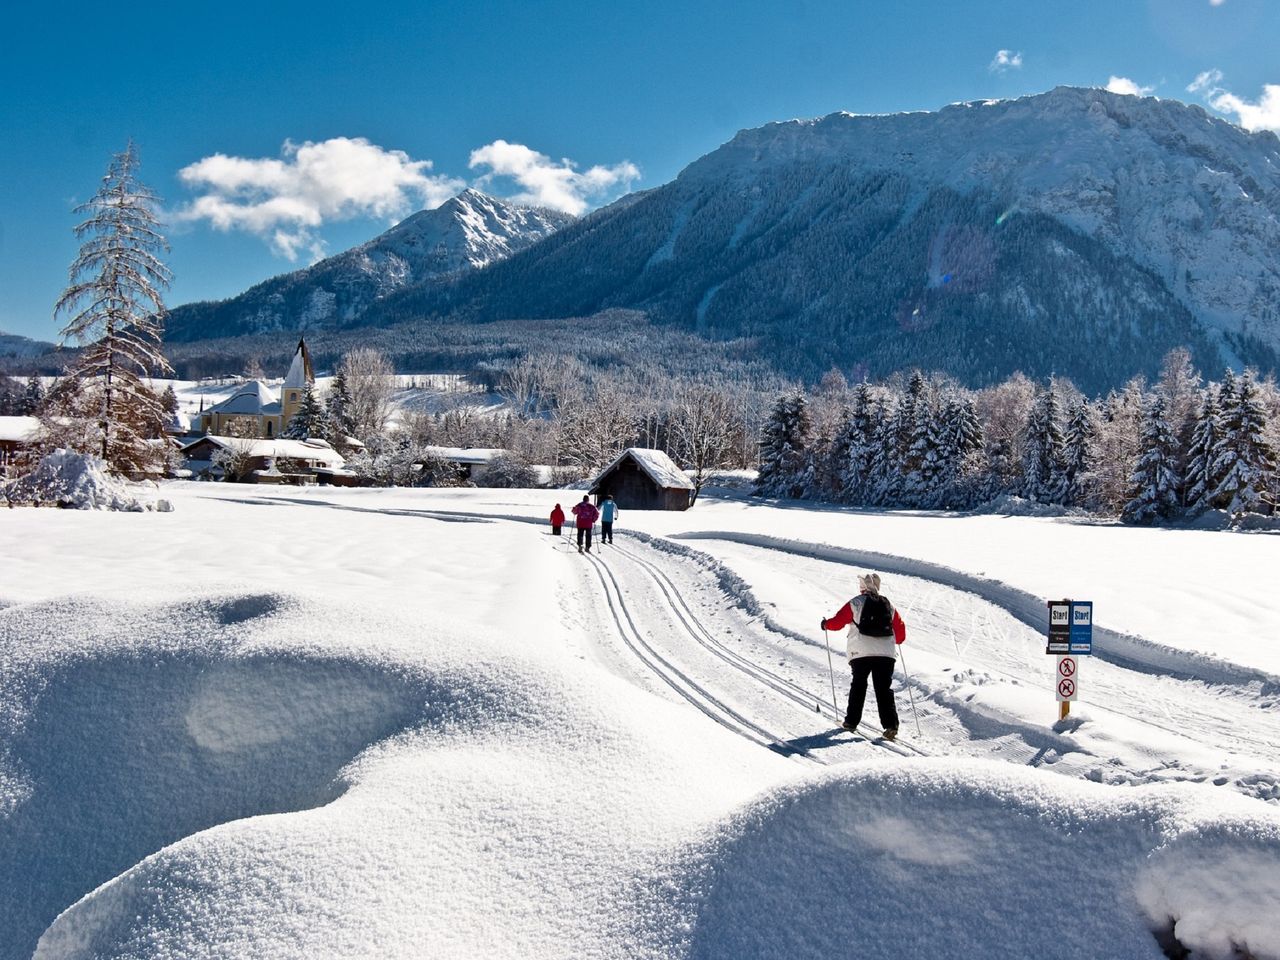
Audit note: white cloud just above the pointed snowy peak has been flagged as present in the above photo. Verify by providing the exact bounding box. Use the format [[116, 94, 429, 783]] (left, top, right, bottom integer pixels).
[[470, 140, 640, 215]]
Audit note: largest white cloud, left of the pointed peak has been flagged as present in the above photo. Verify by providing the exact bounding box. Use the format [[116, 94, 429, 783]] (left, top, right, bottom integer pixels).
[[173, 137, 466, 260]]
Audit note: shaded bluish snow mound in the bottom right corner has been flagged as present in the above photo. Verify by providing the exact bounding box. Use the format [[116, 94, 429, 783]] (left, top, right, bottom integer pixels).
[[689, 760, 1280, 960]]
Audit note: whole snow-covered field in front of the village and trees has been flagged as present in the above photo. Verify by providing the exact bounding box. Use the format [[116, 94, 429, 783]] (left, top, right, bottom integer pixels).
[[0, 483, 1280, 960]]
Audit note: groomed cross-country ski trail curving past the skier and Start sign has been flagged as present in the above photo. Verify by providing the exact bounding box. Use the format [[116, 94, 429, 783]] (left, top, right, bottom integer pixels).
[[235, 497, 1280, 800]]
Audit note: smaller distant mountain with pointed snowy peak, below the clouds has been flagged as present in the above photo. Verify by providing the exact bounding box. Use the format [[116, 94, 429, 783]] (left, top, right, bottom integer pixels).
[[165, 189, 573, 342]]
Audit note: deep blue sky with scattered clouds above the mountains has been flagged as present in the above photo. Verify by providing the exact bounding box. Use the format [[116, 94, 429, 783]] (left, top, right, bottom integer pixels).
[[0, 0, 1280, 339]]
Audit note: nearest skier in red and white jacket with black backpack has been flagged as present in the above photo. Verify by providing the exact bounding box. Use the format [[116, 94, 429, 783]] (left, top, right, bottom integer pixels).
[[822, 573, 906, 740]]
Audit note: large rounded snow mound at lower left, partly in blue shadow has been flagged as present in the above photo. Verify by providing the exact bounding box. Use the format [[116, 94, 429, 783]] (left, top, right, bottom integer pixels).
[[0, 593, 790, 960]]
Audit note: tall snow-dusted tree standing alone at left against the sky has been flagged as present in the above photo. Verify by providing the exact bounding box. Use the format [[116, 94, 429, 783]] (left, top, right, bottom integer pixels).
[[54, 142, 172, 474]]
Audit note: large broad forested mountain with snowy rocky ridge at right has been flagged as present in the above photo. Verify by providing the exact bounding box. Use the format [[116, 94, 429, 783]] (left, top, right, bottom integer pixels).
[[356, 87, 1280, 389]]
